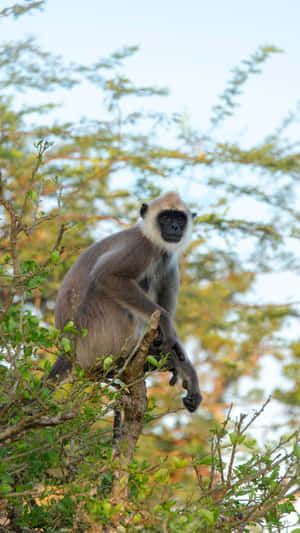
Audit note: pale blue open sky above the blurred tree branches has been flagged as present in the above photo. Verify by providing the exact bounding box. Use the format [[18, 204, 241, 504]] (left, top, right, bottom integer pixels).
[[0, 0, 300, 142]]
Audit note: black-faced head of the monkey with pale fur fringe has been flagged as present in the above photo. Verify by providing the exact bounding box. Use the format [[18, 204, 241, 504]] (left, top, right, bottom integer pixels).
[[140, 192, 196, 253]]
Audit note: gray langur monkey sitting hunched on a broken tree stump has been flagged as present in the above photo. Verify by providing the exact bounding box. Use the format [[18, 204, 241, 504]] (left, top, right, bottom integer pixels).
[[49, 192, 202, 412]]
